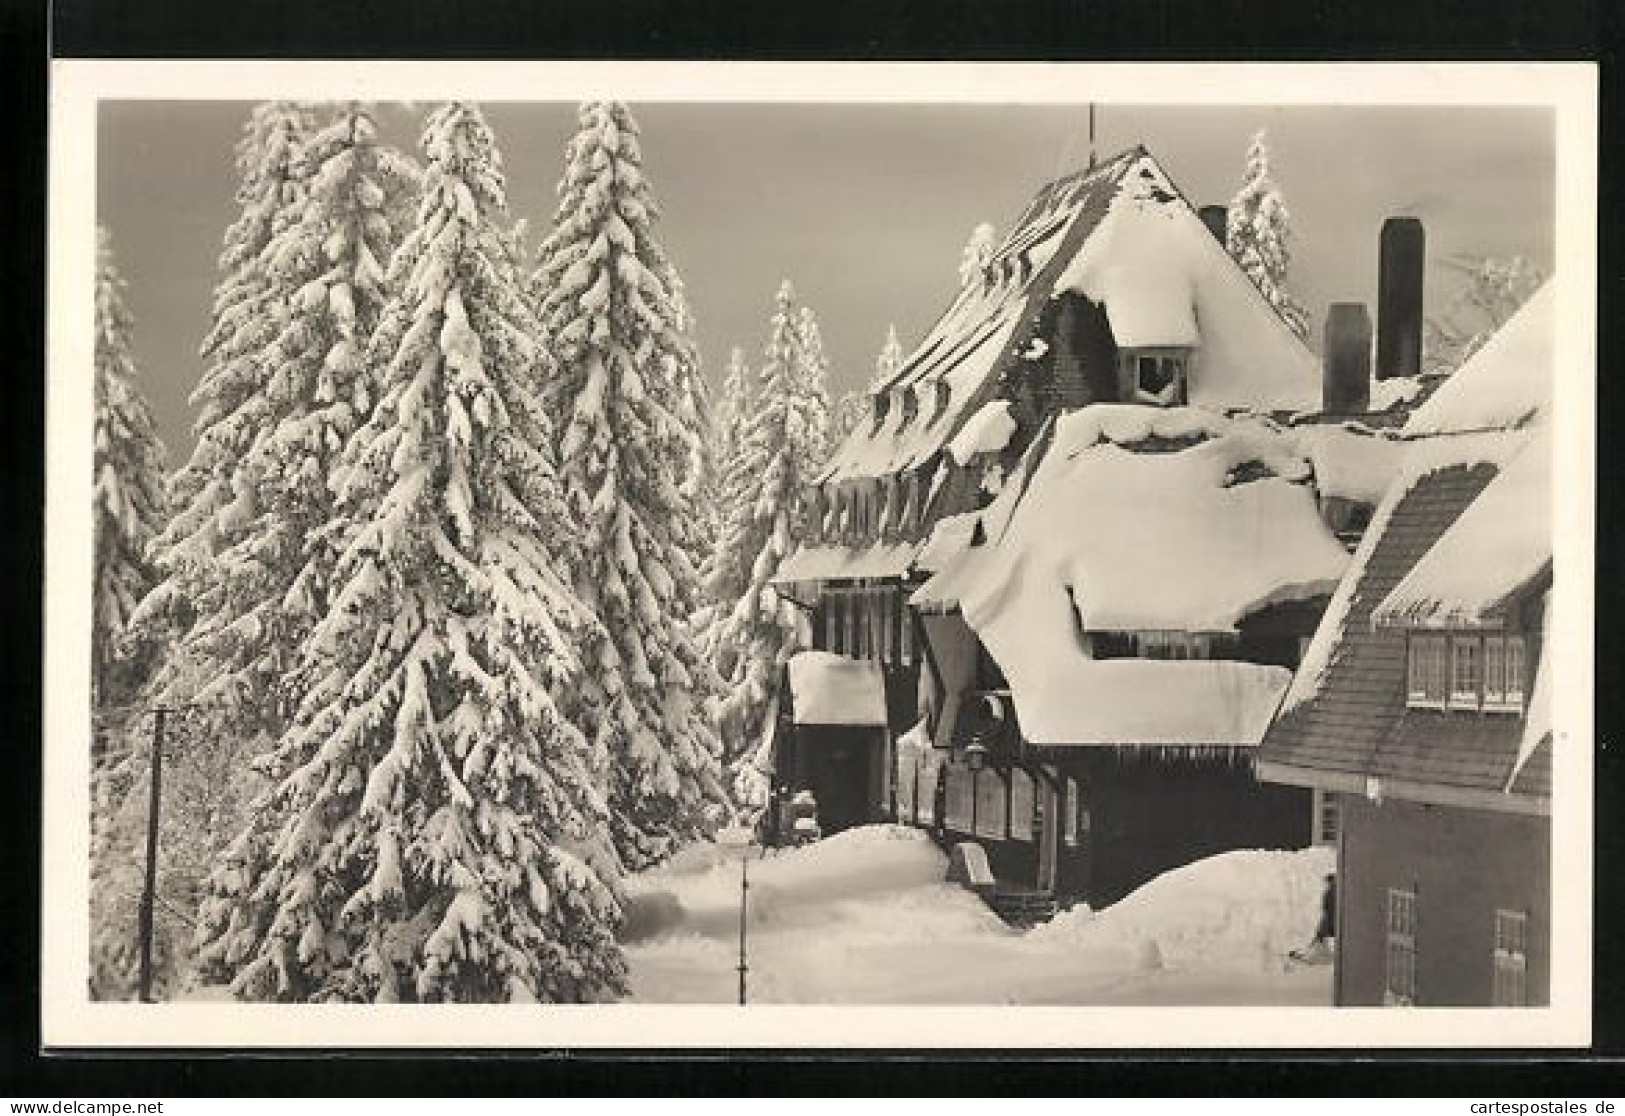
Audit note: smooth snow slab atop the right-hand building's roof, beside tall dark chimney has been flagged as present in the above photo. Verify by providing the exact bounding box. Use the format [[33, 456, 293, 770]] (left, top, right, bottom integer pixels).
[[1404, 279, 1557, 435]]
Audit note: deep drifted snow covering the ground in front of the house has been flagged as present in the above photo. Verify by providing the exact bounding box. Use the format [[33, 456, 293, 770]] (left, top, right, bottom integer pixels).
[[627, 825, 1333, 1006]]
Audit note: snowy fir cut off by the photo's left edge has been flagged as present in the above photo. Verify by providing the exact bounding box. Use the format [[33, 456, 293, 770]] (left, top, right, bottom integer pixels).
[[91, 229, 166, 710]]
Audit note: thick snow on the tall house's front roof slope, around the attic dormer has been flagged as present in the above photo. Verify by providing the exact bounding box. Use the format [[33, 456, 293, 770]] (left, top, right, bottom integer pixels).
[[1055, 156, 1321, 411]]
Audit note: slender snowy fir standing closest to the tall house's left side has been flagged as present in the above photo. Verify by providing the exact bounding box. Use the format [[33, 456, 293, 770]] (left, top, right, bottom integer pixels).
[[707, 283, 826, 786]]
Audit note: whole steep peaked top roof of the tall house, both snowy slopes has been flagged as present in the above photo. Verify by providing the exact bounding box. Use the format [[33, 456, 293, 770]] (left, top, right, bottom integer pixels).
[[819, 148, 1320, 481]]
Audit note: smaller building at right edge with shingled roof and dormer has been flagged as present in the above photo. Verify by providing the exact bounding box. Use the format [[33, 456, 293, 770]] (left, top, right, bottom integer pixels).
[[1259, 284, 1555, 1006]]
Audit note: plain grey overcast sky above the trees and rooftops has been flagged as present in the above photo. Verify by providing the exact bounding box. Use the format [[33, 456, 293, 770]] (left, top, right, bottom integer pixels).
[[96, 101, 1555, 465]]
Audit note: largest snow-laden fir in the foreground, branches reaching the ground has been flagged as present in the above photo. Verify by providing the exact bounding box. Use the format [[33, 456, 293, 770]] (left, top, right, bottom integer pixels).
[[188, 104, 626, 1001]]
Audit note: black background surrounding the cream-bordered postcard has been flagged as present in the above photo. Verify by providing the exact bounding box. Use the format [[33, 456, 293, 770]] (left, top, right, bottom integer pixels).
[[0, 0, 1625, 1103]]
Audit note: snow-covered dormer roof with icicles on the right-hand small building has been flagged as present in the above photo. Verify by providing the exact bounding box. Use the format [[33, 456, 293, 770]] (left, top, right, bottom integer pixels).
[[1372, 427, 1552, 627]]
